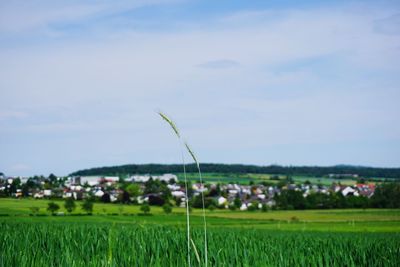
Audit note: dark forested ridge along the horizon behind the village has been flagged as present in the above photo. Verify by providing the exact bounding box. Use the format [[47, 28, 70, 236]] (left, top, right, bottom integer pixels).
[[70, 163, 400, 178]]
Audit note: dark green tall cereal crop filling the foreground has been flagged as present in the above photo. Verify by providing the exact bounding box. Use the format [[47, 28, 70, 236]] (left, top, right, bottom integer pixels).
[[0, 222, 400, 266]]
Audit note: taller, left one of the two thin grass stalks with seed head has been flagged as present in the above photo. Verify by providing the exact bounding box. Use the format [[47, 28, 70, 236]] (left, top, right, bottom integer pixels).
[[157, 111, 191, 266]]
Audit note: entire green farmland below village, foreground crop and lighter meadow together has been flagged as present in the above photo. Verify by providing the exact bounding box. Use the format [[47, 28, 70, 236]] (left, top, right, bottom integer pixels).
[[0, 199, 400, 266]]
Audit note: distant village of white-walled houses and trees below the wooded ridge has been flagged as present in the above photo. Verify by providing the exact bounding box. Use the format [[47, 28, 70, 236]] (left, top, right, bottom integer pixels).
[[0, 174, 384, 210]]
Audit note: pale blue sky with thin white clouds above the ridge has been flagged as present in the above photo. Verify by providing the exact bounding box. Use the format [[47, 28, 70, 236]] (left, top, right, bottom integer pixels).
[[0, 0, 400, 176]]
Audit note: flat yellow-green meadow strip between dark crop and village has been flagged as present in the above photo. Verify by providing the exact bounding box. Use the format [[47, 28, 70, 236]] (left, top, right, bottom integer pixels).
[[0, 199, 400, 232]]
